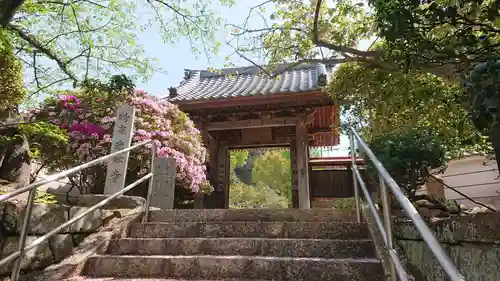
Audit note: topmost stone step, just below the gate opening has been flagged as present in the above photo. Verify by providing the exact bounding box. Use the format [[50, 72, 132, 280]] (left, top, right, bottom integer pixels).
[[149, 208, 355, 222]]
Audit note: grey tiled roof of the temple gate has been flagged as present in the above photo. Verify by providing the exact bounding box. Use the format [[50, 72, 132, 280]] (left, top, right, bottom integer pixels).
[[169, 63, 335, 102]]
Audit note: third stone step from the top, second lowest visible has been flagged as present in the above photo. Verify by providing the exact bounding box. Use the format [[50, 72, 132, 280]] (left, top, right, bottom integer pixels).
[[107, 238, 376, 258]]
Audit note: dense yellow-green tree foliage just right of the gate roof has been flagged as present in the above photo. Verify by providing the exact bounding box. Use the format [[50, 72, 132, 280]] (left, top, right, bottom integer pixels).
[[328, 63, 487, 156]]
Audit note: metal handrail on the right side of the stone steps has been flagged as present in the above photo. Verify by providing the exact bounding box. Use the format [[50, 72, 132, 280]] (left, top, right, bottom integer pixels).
[[350, 128, 465, 281]]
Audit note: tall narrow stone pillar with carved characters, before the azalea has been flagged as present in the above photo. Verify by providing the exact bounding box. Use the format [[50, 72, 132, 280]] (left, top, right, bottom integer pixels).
[[104, 104, 135, 194]]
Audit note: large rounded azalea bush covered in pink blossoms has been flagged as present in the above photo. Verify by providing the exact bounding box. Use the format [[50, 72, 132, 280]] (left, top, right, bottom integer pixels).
[[28, 90, 211, 193]]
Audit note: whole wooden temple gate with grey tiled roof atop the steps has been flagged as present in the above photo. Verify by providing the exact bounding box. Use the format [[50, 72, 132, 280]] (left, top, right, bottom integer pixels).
[[168, 64, 339, 209]]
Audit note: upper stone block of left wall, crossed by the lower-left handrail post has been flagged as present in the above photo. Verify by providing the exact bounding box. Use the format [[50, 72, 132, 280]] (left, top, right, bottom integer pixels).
[[16, 203, 68, 235]]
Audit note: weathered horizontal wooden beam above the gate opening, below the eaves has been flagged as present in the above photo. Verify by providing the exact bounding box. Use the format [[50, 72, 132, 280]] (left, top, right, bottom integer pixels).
[[207, 117, 297, 131]]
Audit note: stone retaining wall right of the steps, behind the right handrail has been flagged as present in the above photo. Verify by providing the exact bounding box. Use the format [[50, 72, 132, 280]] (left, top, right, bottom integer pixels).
[[394, 213, 500, 281]]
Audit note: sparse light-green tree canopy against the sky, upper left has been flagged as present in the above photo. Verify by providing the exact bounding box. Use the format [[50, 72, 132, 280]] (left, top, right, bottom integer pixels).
[[0, 0, 234, 96]]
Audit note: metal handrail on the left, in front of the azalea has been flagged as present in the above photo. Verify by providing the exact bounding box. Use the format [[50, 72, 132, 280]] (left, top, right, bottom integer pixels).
[[0, 140, 156, 281]]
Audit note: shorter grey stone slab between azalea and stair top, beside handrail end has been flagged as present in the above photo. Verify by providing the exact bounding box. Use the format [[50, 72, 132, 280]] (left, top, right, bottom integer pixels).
[[151, 157, 177, 210]]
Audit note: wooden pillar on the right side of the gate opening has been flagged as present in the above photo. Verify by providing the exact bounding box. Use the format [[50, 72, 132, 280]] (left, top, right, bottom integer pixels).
[[295, 116, 311, 209]]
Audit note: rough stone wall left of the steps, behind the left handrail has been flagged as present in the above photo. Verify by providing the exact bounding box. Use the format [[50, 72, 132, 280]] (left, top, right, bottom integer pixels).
[[0, 195, 144, 279]]
